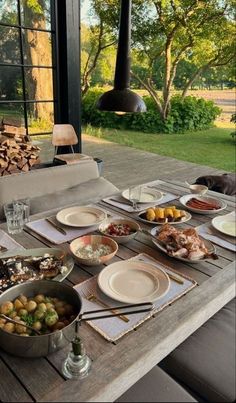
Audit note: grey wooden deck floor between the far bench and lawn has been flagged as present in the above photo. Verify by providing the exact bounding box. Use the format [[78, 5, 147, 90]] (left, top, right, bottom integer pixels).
[[34, 135, 225, 189]]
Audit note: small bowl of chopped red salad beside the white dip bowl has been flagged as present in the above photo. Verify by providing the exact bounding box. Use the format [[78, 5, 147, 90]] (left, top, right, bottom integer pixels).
[[99, 218, 141, 243]]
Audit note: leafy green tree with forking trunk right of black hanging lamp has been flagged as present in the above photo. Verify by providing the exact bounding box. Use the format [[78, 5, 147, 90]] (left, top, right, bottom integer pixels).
[[92, 0, 235, 120]]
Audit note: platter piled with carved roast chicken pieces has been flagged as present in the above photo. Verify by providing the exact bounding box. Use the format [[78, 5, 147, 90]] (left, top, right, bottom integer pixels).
[[151, 224, 218, 263]]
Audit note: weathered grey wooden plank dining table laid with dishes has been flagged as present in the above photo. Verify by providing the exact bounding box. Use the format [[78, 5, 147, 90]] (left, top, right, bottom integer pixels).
[[0, 181, 235, 402]]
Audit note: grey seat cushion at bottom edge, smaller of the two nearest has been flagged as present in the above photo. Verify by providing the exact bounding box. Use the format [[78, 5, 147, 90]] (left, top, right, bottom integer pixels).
[[117, 367, 196, 402]]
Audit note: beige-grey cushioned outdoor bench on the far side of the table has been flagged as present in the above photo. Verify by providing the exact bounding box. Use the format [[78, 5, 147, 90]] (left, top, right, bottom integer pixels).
[[0, 159, 118, 220]]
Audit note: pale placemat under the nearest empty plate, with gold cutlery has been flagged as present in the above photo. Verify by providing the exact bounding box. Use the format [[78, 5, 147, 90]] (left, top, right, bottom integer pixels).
[[74, 253, 197, 341]]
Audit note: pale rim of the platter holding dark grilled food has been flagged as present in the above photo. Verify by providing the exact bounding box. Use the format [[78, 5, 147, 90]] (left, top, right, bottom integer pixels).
[[0, 248, 74, 288]]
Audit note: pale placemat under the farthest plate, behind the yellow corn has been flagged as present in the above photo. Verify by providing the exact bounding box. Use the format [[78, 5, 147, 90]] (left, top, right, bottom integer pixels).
[[103, 193, 178, 213]]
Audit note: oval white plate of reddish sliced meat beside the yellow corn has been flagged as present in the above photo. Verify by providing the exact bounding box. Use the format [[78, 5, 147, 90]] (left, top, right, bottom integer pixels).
[[179, 194, 227, 214]]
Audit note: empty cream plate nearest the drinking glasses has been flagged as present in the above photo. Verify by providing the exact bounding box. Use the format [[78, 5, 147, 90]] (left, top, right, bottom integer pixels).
[[56, 206, 107, 227]]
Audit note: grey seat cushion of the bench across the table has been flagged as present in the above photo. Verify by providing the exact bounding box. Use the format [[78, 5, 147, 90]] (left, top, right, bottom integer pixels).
[[30, 177, 118, 214]]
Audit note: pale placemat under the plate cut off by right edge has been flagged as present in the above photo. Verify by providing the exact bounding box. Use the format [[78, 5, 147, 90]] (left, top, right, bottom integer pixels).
[[197, 213, 236, 252]]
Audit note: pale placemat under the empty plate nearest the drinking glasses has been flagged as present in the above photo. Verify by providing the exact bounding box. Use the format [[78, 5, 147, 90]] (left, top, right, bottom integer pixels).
[[26, 218, 99, 245]]
